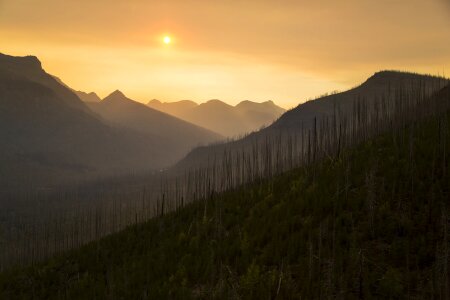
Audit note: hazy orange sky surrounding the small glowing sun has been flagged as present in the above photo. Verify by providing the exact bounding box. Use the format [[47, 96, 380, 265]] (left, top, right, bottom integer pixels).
[[0, 0, 450, 108]]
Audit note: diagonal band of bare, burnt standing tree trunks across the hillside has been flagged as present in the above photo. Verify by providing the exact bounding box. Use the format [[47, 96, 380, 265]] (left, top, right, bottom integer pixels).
[[0, 72, 450, 271]]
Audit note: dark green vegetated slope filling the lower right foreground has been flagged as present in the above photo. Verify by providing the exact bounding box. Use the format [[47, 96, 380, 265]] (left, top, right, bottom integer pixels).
[[0, 114, 450, 299]]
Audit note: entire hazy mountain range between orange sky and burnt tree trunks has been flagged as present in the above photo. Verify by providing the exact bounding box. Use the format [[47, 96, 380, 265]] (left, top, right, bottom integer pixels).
[[0, 54, 448, 190]]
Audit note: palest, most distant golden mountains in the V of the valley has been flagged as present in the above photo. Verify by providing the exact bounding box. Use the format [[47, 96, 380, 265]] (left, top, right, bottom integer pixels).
[[148, 100, 285, 137]]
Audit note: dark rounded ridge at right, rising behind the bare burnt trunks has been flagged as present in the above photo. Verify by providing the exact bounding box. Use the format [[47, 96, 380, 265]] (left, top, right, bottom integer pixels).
[[177, 71, 448, 169]]
